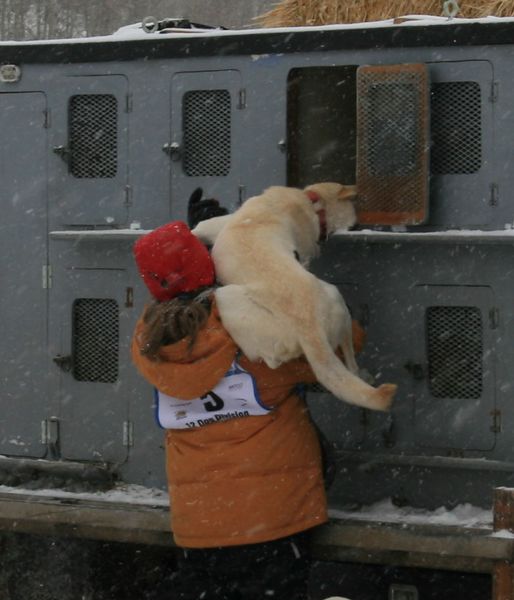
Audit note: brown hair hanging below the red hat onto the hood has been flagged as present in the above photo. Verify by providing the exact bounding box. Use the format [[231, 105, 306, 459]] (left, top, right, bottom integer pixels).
[[140, 297, 211, 361]]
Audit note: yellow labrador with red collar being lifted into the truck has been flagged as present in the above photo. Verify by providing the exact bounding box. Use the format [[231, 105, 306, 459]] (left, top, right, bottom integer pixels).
[[193, 183, 397, 410]]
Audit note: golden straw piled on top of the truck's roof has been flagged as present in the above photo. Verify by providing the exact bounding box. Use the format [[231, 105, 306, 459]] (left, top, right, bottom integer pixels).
[[256, 0, 514, 27]]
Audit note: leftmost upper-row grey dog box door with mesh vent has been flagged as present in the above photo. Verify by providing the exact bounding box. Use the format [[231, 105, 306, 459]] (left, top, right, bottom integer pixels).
[[50, 75, 129, 228]]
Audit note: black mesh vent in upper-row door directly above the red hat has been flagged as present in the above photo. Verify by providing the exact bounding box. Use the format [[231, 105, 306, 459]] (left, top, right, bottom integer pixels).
[[183, 90, 231, 177]]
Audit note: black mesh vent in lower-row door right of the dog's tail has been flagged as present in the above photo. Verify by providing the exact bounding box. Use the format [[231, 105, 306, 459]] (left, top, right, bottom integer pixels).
[[426, 306, 483, 398]]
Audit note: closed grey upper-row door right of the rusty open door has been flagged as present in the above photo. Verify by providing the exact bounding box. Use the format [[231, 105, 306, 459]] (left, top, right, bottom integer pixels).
[[429, 60, 497, 227]]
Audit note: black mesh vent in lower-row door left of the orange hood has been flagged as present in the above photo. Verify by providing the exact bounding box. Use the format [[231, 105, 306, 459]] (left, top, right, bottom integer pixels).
[[73, 298, 119, 383]]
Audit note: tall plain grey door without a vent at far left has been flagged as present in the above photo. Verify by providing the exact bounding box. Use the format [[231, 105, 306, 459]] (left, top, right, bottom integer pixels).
[[0, 92, 52, 457]]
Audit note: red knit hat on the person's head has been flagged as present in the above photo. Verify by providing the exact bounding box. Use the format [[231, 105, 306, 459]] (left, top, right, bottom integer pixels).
[[134, 221, 215, 302]]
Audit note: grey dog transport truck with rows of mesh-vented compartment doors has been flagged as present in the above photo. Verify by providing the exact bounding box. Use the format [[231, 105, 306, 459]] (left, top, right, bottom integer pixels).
[[0, 16, 514, 600]]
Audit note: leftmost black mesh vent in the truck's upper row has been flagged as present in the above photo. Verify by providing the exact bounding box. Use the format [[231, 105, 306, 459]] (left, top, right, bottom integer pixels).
[[69, 94, 118, 178]]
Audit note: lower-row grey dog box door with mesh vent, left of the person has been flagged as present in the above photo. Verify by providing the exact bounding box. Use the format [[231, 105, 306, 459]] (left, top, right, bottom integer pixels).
[[50, 266, 131, 463]]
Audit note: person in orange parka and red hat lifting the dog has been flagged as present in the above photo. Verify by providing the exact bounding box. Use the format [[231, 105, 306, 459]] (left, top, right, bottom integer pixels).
[[132, 216, 360, 600]]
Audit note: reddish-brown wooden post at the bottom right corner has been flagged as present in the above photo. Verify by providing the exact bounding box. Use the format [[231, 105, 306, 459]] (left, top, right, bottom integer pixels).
[[493, 487, 514, 600]]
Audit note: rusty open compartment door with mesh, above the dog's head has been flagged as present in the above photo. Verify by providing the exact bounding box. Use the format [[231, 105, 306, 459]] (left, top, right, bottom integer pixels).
[[357, 64, 430, 225]]
